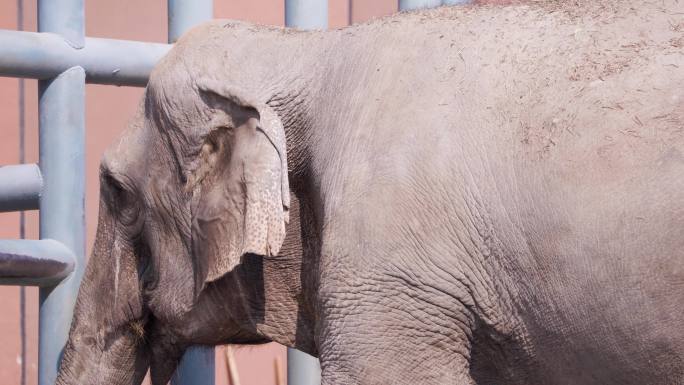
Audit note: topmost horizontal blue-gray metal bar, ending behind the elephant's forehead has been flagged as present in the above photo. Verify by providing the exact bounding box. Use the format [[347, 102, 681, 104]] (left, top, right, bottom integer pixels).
[[0, 30, 171, 87]]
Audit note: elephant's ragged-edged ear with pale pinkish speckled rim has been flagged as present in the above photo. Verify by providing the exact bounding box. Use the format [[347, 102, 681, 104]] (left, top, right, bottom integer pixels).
[[187, 79, 290, 293]]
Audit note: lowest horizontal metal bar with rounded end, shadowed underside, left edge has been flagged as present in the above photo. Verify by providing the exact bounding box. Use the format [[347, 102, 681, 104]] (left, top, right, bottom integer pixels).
[[0, 239, 76, 286]]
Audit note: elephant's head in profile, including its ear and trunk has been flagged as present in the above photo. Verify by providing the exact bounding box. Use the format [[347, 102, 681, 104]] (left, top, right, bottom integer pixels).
[[57, 25, 308, 384]]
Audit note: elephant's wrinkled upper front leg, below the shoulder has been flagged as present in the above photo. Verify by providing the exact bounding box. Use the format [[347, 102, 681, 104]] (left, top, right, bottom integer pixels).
[[318, 274, 474, 385]]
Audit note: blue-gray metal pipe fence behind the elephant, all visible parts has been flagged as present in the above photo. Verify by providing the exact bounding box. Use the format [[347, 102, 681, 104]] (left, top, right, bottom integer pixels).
[[0, 0, 468, 385]]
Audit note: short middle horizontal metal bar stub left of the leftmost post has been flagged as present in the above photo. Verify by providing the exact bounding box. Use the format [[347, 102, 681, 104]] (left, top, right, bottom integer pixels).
[[0, 164, 43, 212]]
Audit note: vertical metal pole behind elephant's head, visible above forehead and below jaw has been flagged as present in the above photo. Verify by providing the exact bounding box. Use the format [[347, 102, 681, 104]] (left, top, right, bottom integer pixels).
[[168, 0, 215, 385]]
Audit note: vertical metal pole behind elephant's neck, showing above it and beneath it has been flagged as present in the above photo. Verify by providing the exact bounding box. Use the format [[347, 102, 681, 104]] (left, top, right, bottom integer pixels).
[[285, 0, 324, 385]]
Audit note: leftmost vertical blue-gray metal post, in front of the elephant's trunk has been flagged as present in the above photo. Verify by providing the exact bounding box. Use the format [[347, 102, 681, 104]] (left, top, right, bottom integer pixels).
[[38, 0, 85, 385]]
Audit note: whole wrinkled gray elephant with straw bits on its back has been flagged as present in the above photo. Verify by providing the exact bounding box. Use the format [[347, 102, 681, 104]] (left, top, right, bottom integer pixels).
[[58, 0, 684, 385]]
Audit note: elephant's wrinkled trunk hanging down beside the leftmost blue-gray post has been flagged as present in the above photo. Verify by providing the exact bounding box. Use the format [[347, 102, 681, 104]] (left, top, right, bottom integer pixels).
[[57, 195, 149, 385]]
